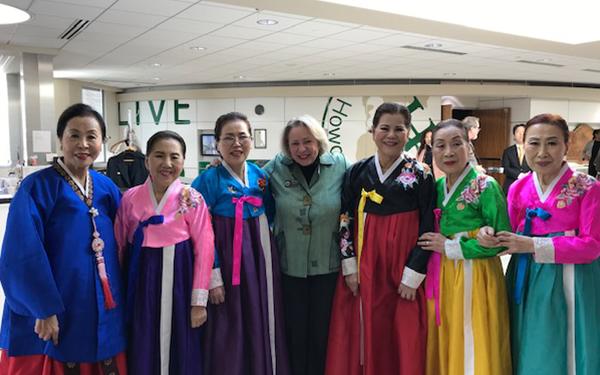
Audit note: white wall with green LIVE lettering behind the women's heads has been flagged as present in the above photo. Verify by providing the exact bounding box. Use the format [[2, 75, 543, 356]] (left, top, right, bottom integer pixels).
[[113, 93, 440, 178]]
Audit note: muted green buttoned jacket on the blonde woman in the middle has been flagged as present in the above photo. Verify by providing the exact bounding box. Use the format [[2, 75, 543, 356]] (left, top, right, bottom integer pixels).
[[263, 152, 350, 277]]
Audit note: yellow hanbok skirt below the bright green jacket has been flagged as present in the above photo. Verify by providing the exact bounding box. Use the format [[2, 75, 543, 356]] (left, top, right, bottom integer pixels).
[[427, 255, 512, 375]]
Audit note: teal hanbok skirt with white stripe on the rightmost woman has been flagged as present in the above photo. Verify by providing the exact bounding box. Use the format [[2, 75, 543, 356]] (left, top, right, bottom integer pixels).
[[506, 236, 600, 375]]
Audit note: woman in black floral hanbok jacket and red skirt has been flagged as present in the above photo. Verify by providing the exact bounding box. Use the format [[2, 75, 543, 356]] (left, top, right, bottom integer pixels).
[[326, 103, 436, 375]]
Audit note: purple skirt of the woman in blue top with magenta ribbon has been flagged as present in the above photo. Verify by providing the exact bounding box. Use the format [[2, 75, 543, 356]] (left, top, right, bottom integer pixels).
[[203, 215, 290, 375]]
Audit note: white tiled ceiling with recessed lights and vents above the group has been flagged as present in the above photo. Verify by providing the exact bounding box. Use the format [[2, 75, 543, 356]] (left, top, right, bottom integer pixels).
[[0, 0, 600, 88]]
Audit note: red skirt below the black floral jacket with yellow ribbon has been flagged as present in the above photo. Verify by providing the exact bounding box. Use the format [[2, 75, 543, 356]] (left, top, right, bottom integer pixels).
[[325, 211, 427, 375]]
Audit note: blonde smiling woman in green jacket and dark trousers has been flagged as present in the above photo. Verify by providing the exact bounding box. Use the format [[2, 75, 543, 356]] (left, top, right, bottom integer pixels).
[[263, 115, 350, 375]]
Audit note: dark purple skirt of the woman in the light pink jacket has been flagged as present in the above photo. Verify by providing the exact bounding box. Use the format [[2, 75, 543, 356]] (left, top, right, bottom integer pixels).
[[128, 239, 203, 375]]
